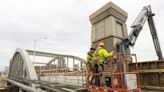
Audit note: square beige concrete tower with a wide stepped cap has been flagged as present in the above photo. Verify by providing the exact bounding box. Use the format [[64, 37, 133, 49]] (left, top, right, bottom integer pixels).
[[89, 2, 130, 53]]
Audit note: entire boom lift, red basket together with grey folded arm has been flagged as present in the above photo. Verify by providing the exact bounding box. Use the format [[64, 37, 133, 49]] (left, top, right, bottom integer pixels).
[[84, 5, 163, 92]]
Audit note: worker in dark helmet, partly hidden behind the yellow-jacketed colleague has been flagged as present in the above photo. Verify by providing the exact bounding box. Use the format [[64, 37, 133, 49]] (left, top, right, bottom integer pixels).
[[86, 48, 95, 84]]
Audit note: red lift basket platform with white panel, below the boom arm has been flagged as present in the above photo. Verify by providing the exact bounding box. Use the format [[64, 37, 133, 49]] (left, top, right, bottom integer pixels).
[[84, 53, 141, 92]]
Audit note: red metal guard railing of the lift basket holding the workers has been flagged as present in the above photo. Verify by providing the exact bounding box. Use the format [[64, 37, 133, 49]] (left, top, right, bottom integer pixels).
[[84, 54, 141, 92]]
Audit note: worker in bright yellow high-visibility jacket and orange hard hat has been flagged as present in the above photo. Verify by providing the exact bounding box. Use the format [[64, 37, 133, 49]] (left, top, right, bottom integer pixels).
[[93, 42, 113, 86]]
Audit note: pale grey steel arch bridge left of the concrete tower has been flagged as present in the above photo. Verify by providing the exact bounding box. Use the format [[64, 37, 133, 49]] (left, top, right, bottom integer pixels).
[[6, 48, 86, 92]]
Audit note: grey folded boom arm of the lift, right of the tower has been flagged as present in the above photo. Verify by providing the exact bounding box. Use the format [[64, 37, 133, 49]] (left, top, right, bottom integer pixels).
[[116, 5, 163, 60]]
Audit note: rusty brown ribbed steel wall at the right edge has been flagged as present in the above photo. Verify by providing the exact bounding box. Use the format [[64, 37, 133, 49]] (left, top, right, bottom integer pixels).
[[128, 60, 164, 92]]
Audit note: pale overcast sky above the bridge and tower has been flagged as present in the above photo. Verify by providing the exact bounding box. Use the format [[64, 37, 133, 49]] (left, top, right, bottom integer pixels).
[[0, 0, 164, 70]]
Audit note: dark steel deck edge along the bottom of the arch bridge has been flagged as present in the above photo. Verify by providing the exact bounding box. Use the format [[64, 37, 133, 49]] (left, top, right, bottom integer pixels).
[[7, 78, 82, 92]]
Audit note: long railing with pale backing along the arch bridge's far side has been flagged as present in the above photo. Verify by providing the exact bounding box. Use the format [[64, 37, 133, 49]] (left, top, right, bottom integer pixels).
[[32, 63, 86, 86]]
